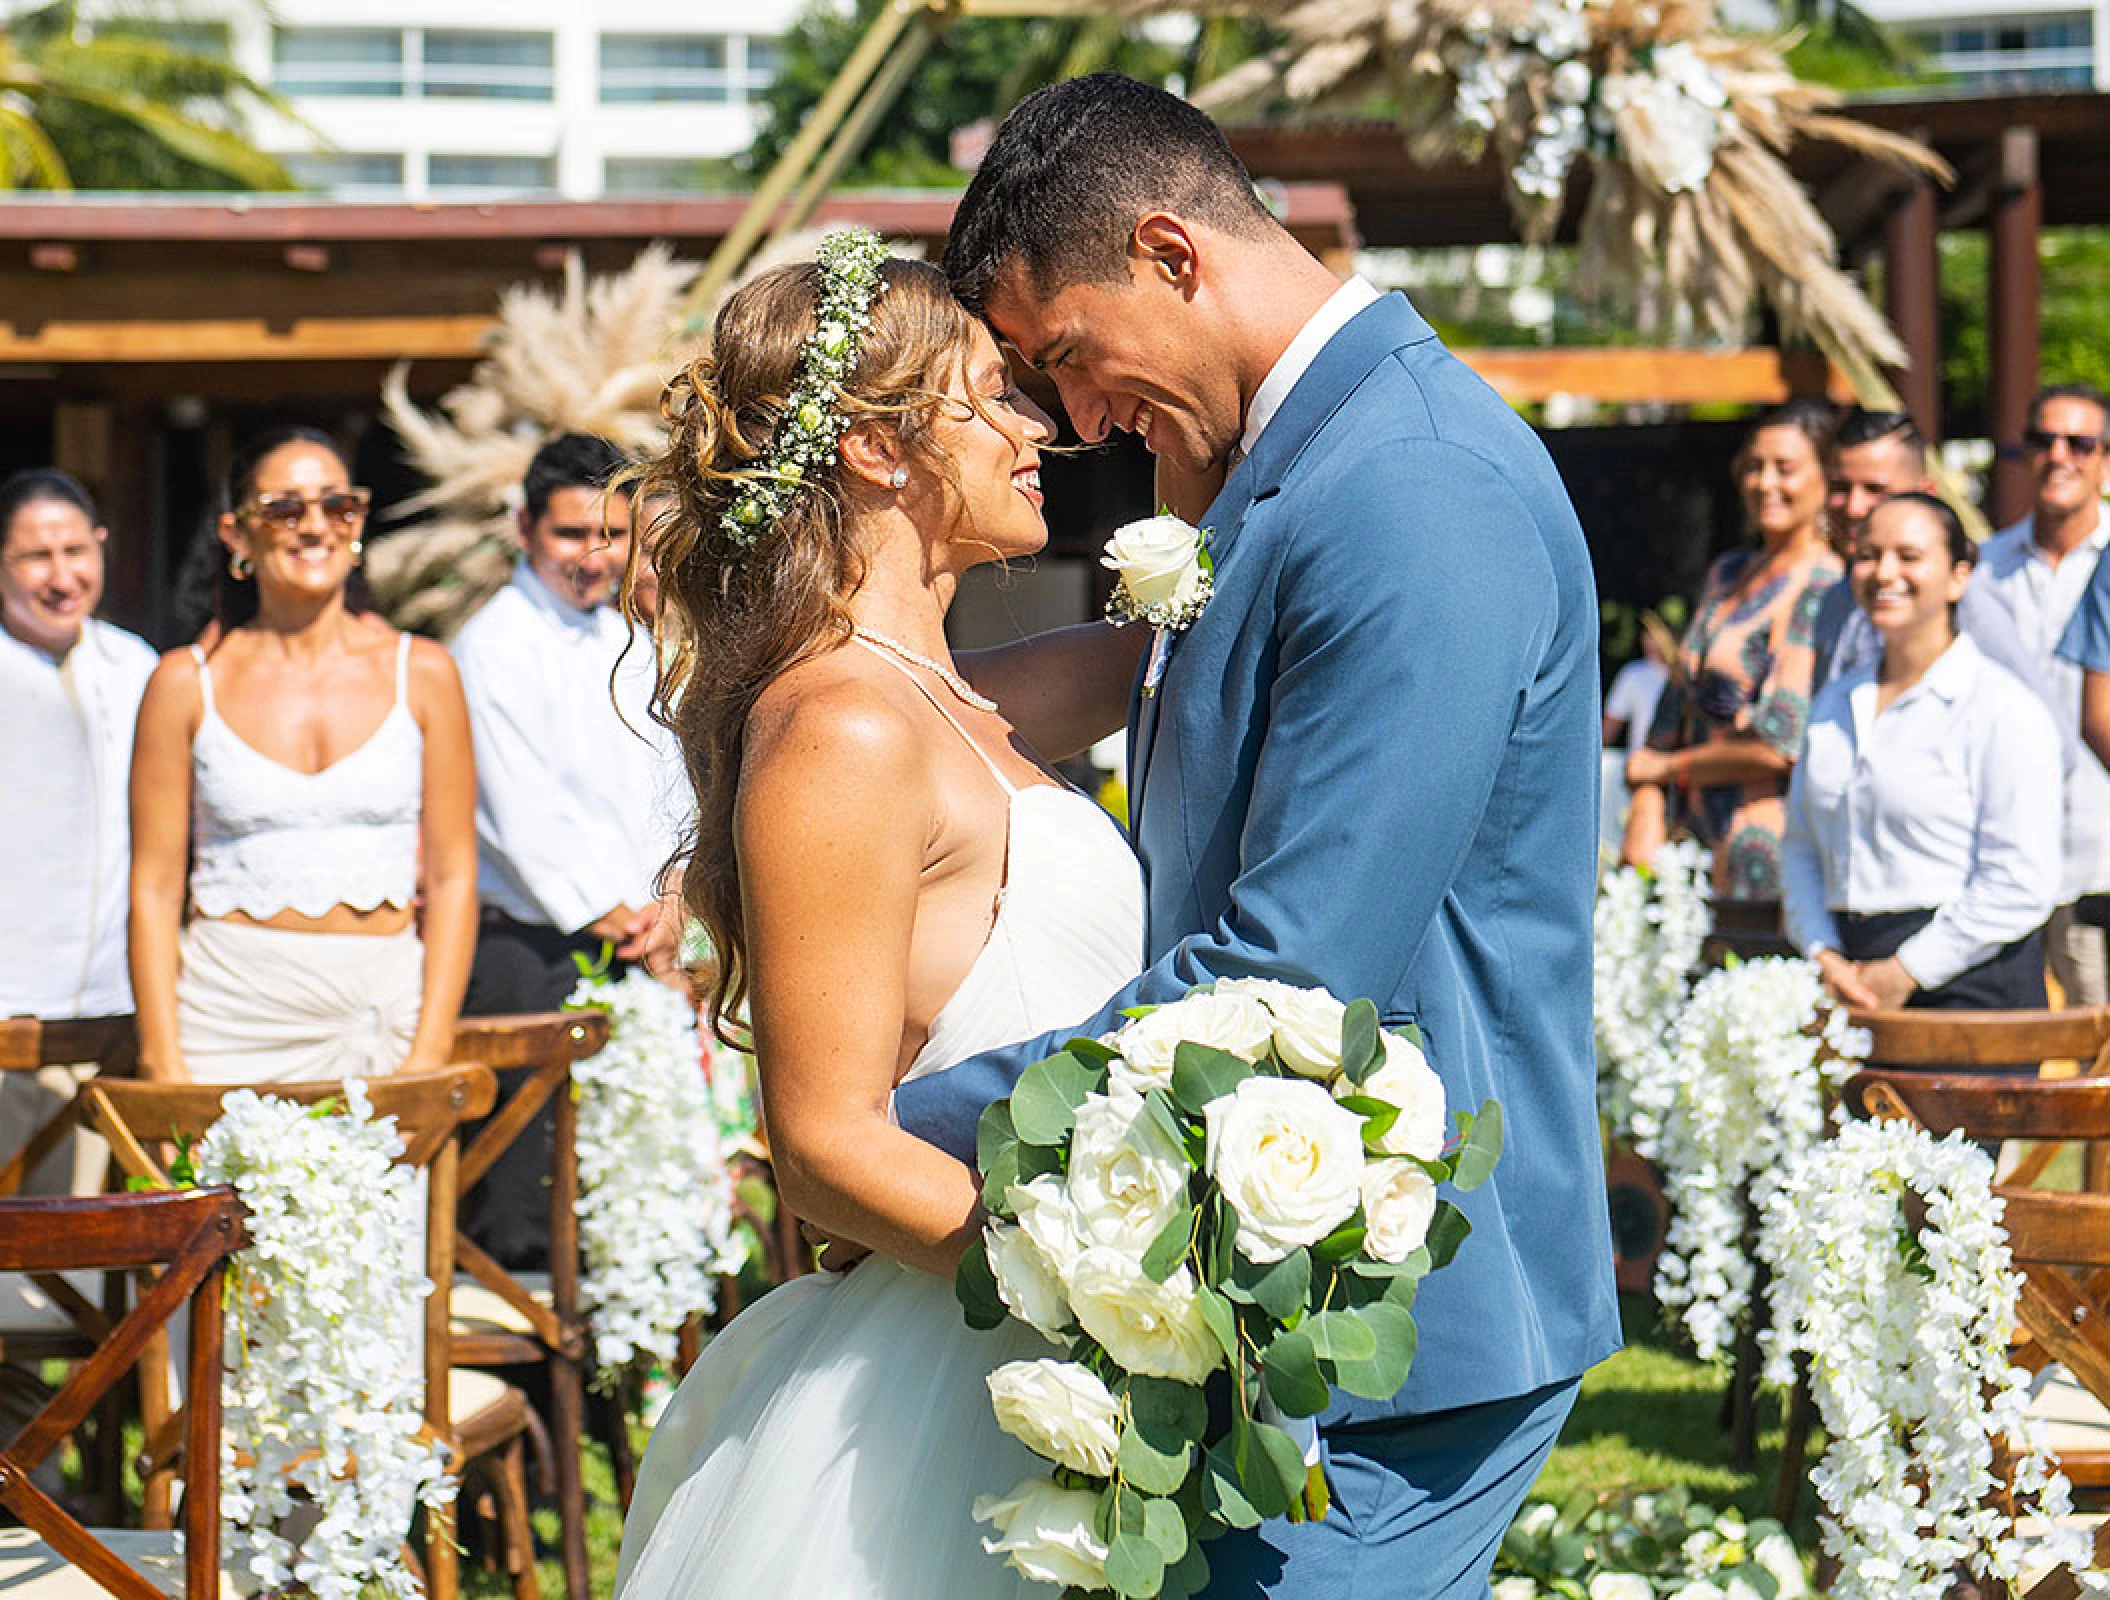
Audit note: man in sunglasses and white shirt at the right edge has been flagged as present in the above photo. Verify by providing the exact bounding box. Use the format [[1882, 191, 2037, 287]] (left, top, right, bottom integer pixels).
[[1971, 384, 2110, 1005]]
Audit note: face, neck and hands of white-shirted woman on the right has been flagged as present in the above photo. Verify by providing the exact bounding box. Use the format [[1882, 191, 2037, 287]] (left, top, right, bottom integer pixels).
[[1817, 500, 1971, 1011]]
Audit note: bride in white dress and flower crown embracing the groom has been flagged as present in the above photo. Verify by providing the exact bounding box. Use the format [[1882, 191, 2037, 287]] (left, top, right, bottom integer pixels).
[[616, 232, 1144, 1600]]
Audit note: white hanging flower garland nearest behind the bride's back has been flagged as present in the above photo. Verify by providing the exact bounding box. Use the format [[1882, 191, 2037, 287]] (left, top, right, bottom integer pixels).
[[565, 971, 747, 1378]]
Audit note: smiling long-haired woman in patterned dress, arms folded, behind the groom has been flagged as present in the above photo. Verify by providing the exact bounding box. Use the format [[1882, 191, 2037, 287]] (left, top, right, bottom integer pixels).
[[1620, 401, 1844, 899]]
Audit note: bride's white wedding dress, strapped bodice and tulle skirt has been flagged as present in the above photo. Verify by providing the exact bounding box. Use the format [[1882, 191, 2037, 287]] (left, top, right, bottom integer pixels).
[[616, 652, 1144, 1600]]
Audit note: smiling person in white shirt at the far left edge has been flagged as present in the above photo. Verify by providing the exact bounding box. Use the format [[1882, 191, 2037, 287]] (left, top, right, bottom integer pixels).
[[0, 469, 154, 1191]]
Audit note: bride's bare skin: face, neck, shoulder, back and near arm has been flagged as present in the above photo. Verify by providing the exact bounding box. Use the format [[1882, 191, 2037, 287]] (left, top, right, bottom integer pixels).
[[734, 329, 1088, 1277]]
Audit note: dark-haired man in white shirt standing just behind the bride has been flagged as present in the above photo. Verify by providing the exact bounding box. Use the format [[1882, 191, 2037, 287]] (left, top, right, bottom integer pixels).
[[452, 433, 682, 1266]]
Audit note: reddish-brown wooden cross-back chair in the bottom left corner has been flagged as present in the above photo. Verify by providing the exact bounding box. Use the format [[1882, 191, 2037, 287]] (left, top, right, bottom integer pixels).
[[0, 1188, 247, 1600]]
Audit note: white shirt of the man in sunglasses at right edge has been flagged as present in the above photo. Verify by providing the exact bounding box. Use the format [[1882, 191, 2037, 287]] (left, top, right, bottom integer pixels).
[[1971, 513, 2110, 906]]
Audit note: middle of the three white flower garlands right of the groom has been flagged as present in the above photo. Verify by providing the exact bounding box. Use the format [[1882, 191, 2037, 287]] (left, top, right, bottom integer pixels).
[[1633, 956, 1869, 1359]]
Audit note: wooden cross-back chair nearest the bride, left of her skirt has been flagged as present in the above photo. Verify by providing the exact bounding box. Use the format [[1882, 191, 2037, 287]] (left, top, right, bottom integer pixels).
[[447, 1011, 607, 1600]]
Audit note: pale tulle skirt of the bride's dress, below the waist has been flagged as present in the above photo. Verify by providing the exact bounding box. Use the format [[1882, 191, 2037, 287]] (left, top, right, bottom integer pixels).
[[616, 1256, 1055, 1600]]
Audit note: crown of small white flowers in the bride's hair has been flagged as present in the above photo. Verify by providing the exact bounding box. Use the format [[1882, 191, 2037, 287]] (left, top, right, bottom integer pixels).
[[717, 228, 886, 549]]
